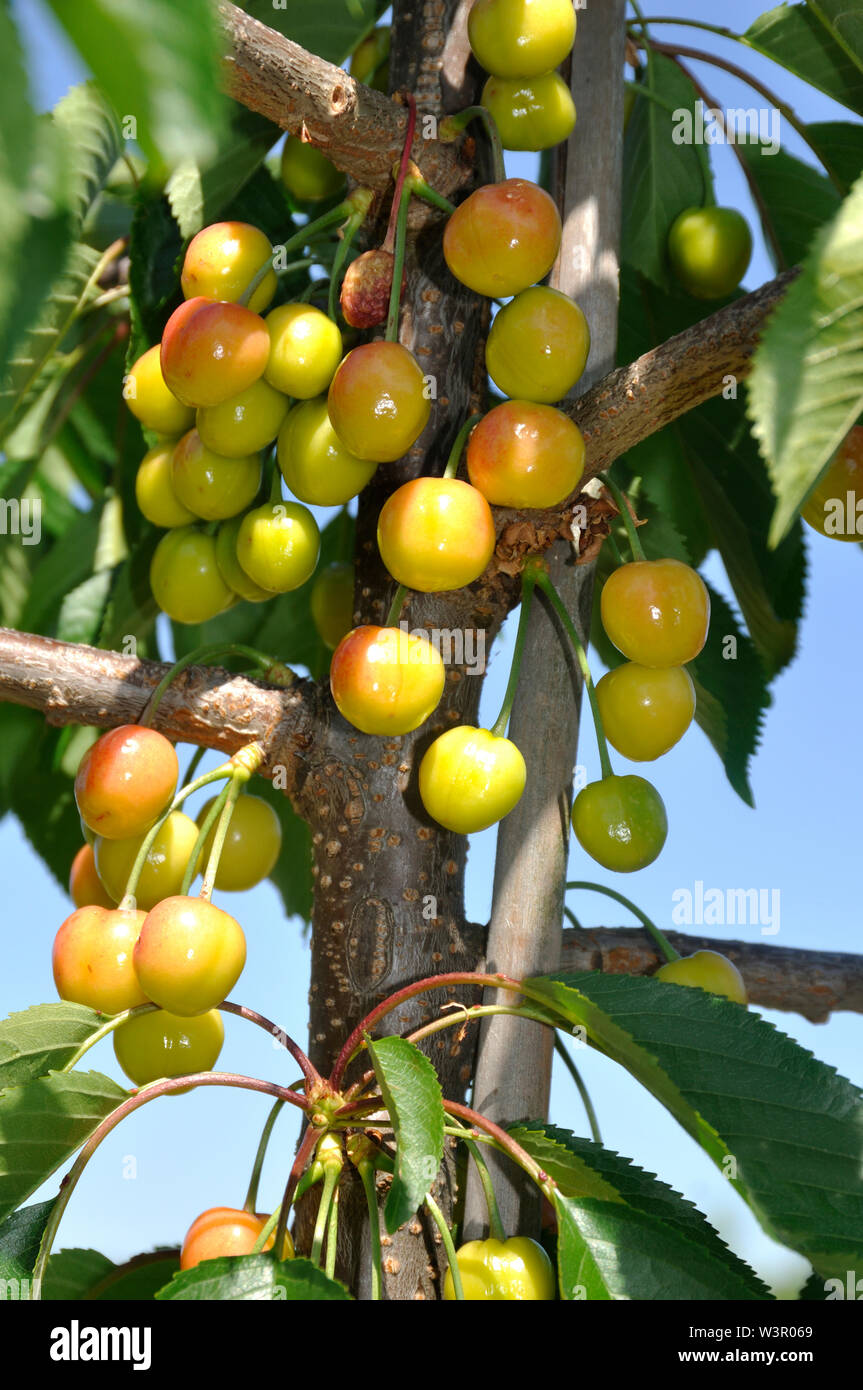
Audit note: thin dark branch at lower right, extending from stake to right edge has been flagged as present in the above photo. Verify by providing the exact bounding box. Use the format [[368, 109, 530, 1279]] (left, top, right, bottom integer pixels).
[[560, 927, 863, 1023]]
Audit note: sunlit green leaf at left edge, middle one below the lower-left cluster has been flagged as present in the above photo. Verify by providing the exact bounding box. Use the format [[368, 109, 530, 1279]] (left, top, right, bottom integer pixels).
[[0, 1072, 128, 1220]]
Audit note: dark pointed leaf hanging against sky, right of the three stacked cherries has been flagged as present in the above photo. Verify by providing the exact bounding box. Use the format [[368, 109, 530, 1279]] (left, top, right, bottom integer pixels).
[[687, 585, 771, 806]]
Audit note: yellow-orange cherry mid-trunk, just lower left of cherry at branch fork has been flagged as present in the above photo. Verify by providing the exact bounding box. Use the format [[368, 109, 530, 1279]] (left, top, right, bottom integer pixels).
[[378, 478, 495, 594]]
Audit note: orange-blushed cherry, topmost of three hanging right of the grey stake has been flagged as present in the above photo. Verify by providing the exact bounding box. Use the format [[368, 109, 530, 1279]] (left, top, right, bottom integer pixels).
[[600, 560, 710, 666]]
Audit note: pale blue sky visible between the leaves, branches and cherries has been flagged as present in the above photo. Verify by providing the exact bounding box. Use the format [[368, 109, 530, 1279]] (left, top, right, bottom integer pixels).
[[0, 0, 863, 1286]]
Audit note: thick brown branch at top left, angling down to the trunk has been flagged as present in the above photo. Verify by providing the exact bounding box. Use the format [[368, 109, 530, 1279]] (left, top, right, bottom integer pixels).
[[220, 3, 472, 201]]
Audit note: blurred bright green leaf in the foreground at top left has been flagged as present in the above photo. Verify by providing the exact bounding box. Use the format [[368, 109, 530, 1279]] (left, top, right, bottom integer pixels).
[[49, 0, 227, 165]]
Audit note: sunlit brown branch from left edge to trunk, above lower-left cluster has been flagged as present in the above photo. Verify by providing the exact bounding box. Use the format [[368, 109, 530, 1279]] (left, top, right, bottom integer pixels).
[[0, 628, 314, 785]]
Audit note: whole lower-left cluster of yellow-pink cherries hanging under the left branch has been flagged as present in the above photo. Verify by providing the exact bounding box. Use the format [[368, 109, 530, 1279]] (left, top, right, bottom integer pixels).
[[61, 724, 282, 1086]]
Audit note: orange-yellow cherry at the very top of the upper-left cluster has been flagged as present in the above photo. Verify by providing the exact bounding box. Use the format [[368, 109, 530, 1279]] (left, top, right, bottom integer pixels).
[[179, 222, 278, 314]]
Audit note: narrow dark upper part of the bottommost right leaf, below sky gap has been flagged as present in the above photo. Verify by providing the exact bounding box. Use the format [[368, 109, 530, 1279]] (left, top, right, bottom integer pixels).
[[510, 1120, 770, 1298]]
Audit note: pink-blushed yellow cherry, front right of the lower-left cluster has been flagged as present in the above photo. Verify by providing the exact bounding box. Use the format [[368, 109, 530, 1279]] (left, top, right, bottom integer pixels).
[[135, 897, 246, 1017]]
